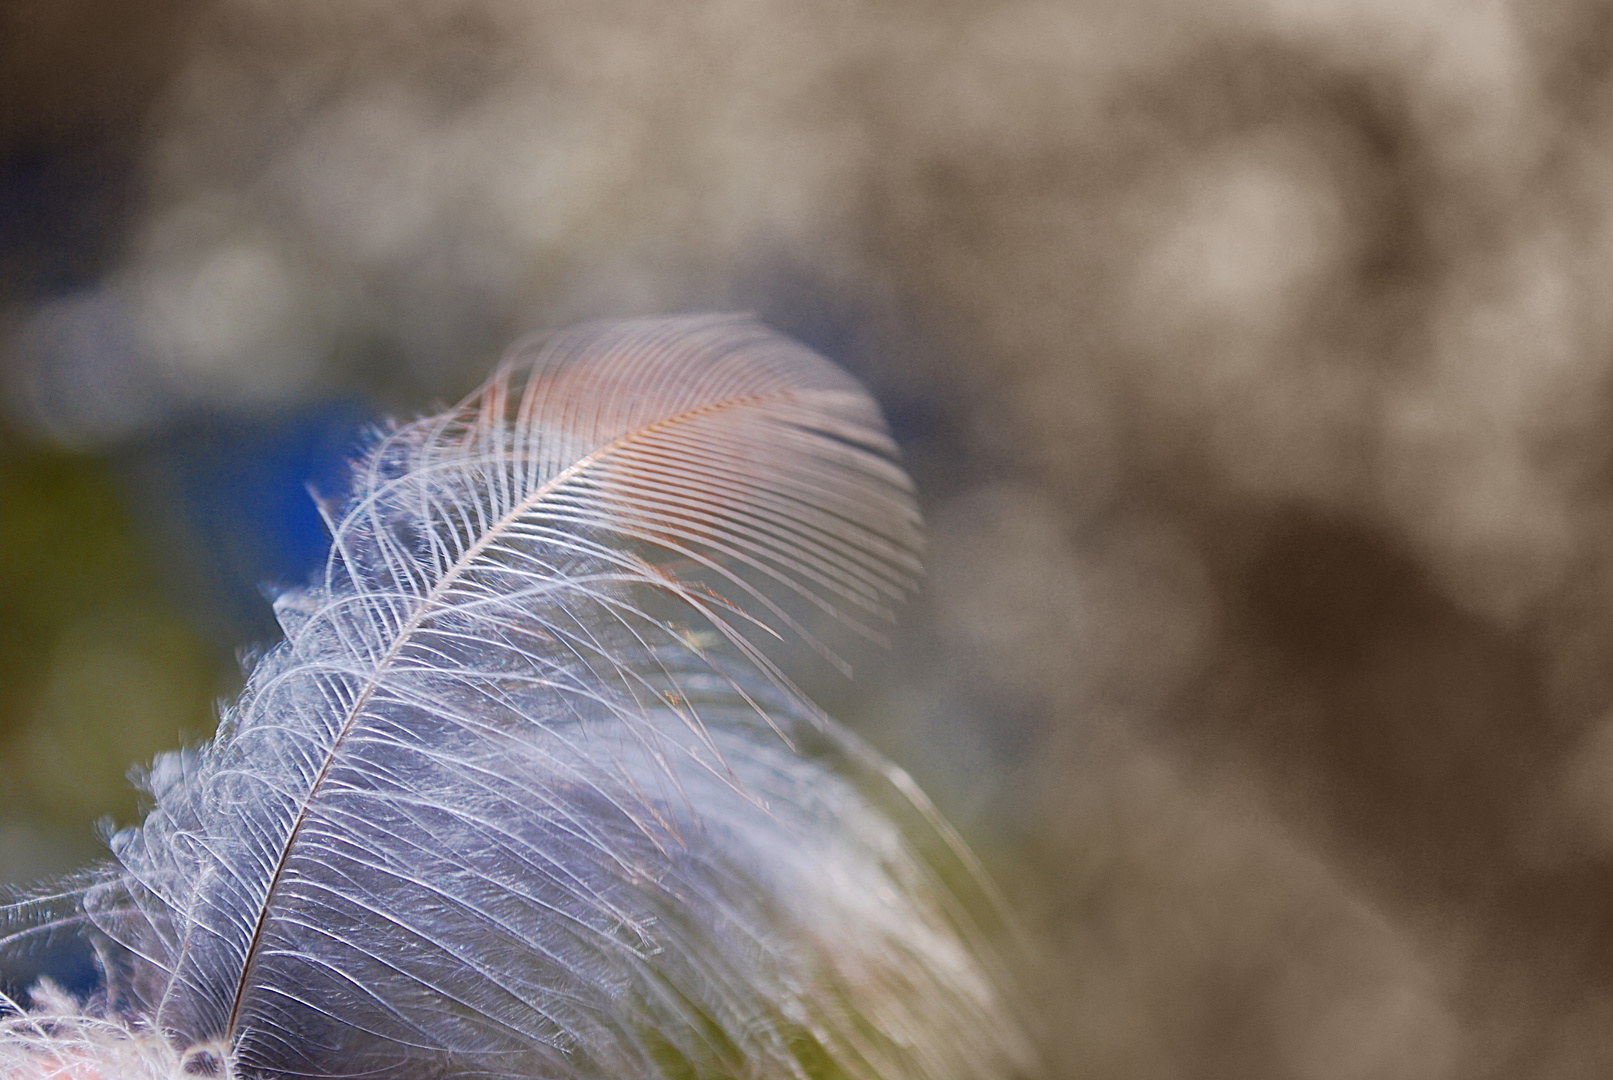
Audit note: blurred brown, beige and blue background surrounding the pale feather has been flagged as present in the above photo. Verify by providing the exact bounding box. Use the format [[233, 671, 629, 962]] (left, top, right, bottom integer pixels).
[[9, 0, 1613, 1080]]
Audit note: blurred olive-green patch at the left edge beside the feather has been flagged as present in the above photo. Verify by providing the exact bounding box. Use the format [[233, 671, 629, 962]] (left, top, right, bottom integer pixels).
[[0, 434, 219, 832]]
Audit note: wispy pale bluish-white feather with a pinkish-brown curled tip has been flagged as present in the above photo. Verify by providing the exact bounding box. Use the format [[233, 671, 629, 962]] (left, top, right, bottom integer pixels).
[[0, 316, 1032, 1080]]
